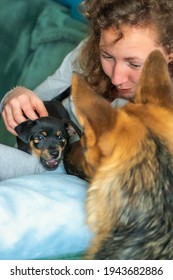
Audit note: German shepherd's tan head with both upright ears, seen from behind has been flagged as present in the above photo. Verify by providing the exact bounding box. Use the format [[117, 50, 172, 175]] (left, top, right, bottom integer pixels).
[[72, 51, 173, 177]]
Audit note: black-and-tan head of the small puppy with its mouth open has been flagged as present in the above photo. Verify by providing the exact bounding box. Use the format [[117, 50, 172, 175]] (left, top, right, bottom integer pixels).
[[15, 117, 77, 170]]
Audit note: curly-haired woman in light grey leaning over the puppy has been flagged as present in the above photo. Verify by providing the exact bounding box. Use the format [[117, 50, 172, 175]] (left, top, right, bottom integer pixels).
[[0, 0, 173, 179]]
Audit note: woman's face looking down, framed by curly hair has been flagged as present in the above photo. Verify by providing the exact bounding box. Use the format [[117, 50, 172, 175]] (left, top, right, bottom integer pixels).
[[99, 26, 168, 100]]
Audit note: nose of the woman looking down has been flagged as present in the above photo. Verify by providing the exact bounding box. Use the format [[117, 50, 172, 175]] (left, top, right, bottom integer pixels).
[[110, 63, 128, 86]]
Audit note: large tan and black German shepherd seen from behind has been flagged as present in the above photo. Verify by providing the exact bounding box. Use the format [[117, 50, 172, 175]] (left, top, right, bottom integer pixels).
[[72, 51, 173, 260]]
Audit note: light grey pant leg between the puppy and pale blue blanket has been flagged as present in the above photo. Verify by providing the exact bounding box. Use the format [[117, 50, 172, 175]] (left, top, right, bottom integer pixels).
[[0, 144, 46, 181]]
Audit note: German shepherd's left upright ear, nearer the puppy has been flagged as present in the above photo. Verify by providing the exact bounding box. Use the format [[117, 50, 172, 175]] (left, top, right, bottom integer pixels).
[[72, 74, 115, 147]]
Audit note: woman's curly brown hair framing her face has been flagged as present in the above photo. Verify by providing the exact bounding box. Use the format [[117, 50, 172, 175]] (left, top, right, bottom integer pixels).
[[79, 0, 173, 100]]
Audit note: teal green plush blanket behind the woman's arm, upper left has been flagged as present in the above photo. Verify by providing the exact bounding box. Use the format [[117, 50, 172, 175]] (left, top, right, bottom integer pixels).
[[0, 0, 87, 145]]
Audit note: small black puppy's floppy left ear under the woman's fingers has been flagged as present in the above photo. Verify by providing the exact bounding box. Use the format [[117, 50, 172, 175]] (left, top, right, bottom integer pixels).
[[15, 120, 36, 144]]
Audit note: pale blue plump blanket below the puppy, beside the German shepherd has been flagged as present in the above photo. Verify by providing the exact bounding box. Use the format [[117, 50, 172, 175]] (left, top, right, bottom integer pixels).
[[0, 167, 91, 260]]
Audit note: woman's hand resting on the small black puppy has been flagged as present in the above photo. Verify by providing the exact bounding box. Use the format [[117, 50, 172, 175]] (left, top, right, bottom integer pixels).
[[2, 87, 48, 135]]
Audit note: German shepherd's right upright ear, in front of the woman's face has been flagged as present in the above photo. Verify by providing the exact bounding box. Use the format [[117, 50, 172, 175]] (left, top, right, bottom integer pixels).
[[134, 50, 173, 107]]
